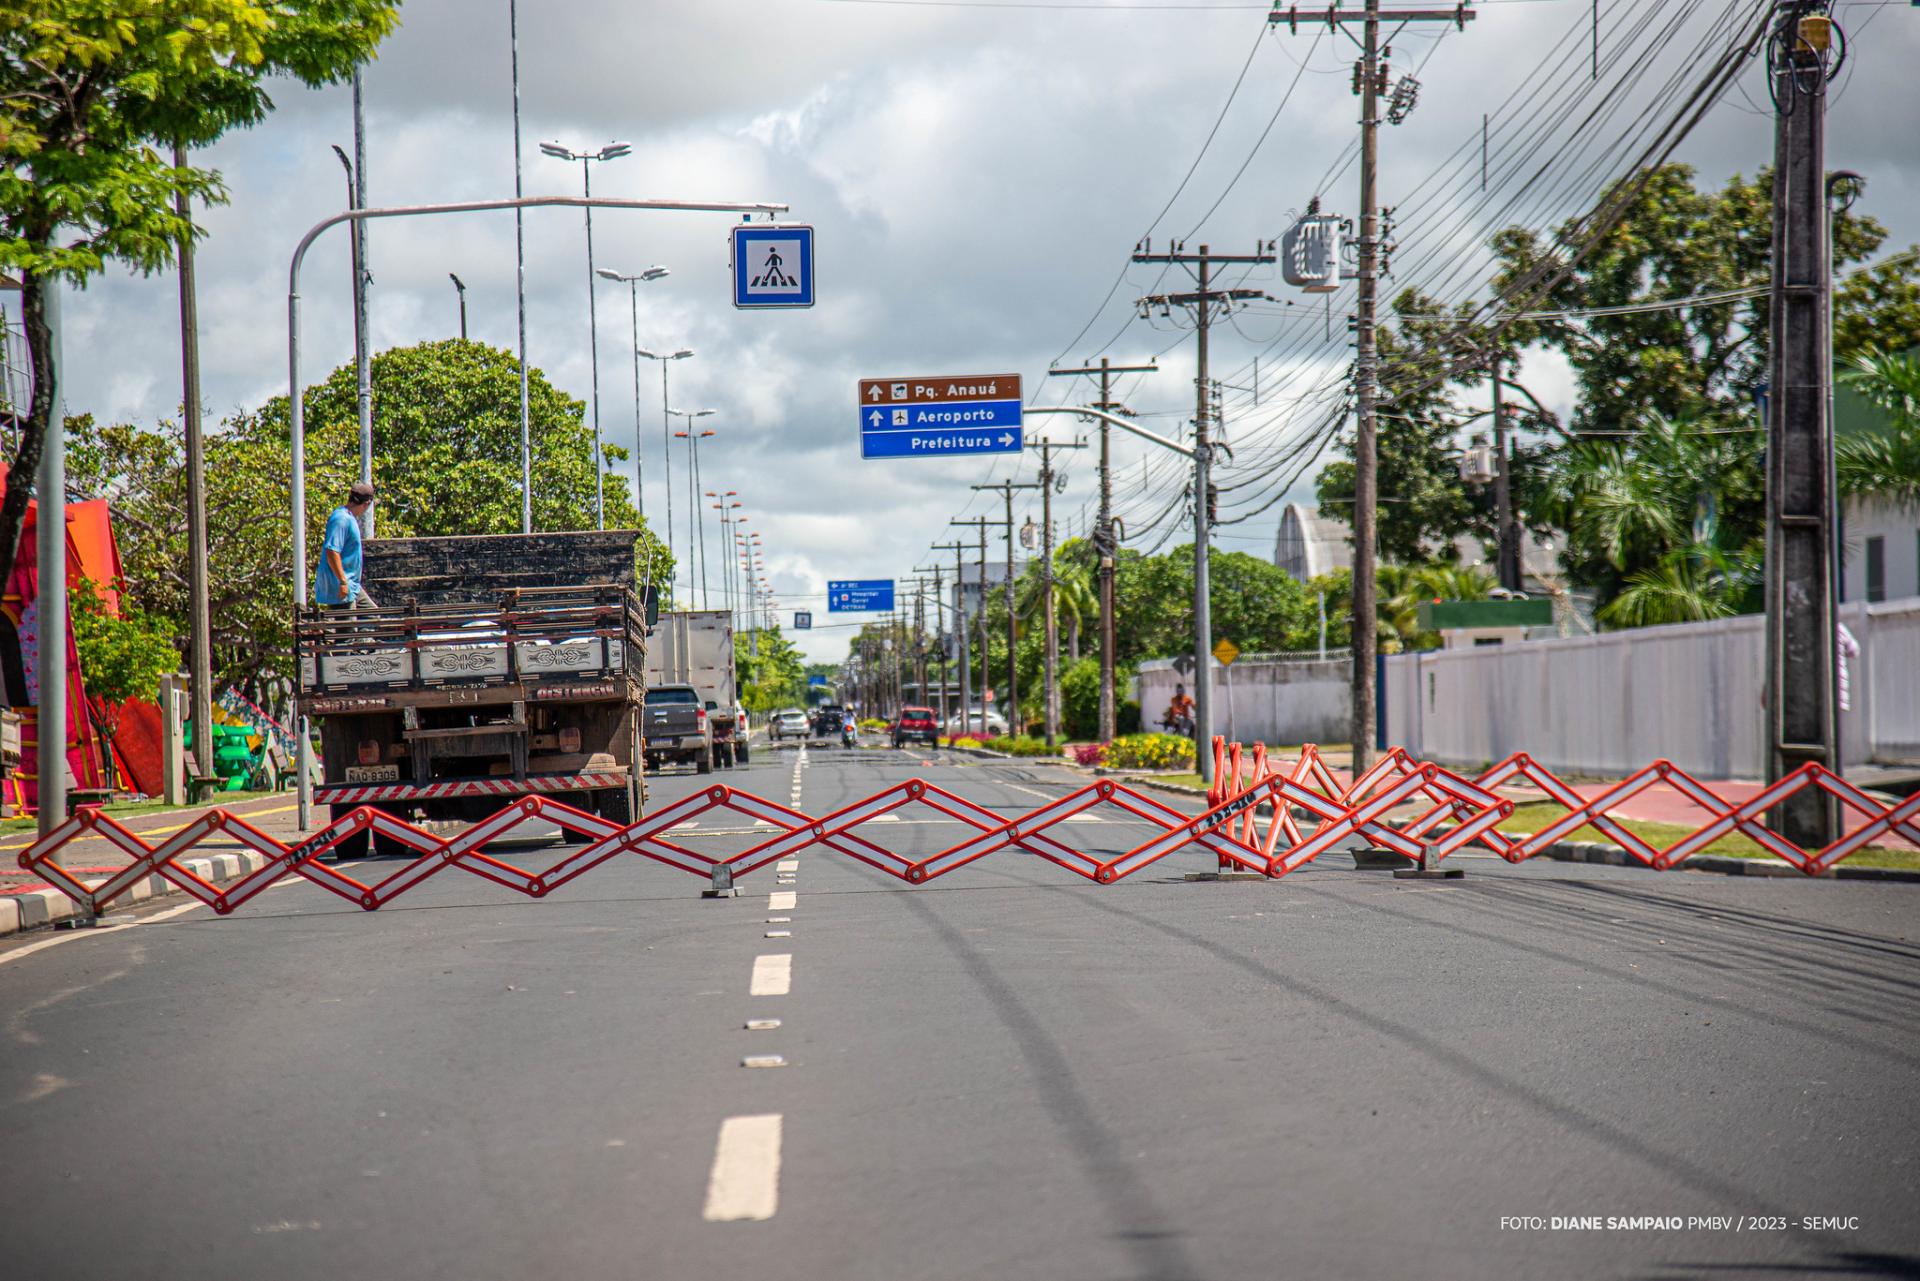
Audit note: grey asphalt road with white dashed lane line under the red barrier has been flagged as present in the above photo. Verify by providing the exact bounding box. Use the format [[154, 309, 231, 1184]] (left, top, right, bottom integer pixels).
[[0, 749, 1920, 1281]]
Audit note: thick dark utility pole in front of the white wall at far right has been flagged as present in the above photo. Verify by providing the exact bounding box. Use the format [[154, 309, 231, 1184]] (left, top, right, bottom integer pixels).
[[1766, 0, 1839, 849]]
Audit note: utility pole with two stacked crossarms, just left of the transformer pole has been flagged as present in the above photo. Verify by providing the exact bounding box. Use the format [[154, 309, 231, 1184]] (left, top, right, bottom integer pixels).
[[1133, 240, 1274, 784]]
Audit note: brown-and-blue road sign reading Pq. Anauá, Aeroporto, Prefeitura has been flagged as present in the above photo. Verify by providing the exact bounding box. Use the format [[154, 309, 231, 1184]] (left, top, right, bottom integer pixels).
[[860, 375, 1025, 459]]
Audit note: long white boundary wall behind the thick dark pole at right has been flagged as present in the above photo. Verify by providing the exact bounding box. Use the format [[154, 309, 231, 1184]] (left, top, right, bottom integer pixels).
[[1382, 599, 1920, 778]]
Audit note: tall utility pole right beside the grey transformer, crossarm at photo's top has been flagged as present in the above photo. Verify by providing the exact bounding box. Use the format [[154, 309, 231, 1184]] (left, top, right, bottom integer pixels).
[[1267, 0, 1478, 776]]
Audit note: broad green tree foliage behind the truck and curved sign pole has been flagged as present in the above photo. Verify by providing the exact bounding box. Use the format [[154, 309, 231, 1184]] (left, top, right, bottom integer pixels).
[[67, 340, 672, 691]]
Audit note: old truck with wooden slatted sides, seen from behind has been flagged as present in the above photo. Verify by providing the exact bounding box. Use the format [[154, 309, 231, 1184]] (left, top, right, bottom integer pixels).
[[294, 532, 651, 855]]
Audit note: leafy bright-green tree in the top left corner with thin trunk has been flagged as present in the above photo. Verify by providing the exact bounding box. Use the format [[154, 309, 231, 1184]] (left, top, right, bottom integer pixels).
[[0, 0, 399, 603]]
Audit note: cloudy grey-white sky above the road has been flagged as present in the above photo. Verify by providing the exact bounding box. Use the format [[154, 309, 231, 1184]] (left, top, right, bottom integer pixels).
[[33, 0, 1920, 659]]
